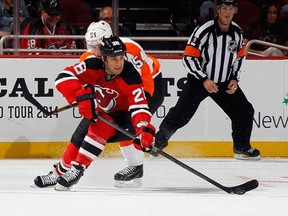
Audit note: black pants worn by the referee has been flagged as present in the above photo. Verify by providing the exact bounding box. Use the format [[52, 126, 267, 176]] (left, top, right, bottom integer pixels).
[[159, 75, 254, 150]]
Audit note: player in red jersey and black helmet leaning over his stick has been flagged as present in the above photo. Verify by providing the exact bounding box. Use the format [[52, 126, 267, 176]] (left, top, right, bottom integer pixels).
[[35, 37, 155, 190]]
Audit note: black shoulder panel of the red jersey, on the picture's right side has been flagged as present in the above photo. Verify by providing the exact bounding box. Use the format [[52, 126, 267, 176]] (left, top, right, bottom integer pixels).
[[120, 60, 142, 85]]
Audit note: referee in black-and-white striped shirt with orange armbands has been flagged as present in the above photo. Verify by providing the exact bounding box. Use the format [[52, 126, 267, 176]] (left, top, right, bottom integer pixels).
[[151, 0, 260, 160]]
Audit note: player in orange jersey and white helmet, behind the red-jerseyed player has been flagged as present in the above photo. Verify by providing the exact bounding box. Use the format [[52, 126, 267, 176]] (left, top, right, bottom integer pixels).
[[80, 21, 165, 187]]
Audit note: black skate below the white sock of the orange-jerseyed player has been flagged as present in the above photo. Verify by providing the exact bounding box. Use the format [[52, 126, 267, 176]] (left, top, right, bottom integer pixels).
[[114, 165, 143, 188]]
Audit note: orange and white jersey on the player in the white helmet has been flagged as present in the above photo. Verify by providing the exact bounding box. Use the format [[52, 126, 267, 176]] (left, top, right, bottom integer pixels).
[[80, 37, 161, 96]]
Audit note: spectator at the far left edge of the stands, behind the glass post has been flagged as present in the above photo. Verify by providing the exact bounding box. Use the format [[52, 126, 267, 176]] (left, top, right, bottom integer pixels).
[[0, 0, 29, 37]]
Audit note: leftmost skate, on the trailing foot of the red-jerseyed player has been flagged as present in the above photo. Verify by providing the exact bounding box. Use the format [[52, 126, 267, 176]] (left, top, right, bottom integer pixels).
[[31, 165, 59, 188]]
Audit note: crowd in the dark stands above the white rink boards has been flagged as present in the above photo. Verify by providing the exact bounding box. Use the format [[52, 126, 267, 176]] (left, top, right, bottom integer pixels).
[[0, 0, 288, 55]]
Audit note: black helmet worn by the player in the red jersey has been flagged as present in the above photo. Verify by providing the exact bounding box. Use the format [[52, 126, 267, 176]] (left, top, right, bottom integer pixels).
[[100, 36, 126, 56]]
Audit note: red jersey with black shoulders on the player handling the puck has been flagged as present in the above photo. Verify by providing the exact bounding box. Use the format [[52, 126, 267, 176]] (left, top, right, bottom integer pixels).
[[55, 58, 151, 127]]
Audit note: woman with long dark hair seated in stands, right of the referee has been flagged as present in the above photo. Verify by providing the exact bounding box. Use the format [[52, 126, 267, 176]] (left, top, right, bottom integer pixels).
[[244, 2, 283, 56]]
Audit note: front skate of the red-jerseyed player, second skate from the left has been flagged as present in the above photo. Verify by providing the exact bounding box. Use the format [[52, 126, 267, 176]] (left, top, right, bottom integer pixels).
[[55, 164, 85, 191]]
